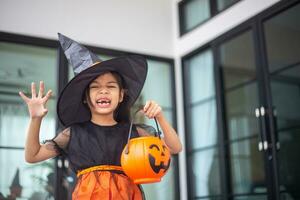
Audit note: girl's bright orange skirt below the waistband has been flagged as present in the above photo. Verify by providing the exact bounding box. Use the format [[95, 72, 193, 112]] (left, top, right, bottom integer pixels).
[[72, 171, 143, 200]]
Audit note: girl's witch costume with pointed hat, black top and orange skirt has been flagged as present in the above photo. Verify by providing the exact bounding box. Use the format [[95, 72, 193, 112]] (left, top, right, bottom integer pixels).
[[47, 34, 155, 200]]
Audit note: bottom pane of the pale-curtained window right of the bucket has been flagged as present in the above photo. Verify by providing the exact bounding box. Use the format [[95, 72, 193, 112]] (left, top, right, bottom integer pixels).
[[188, 148, 221, 197]]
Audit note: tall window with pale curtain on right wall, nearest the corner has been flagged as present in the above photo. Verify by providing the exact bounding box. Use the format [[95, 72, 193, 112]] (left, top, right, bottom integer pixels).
[[183, 49, 221, 199]]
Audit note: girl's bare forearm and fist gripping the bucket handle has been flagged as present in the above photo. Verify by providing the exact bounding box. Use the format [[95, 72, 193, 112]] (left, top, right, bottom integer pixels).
[[143, 101, 182, 154]]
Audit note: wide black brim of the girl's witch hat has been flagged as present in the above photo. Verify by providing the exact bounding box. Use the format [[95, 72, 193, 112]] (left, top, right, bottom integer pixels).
[[57, 55, 148, 127]]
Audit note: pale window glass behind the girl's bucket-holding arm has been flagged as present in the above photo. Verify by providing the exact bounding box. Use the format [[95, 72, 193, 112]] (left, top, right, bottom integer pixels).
[[133, 59, 177, 200]]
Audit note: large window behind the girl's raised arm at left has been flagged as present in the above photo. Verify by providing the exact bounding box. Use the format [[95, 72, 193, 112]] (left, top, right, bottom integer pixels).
[[0, 42, 57, 199]]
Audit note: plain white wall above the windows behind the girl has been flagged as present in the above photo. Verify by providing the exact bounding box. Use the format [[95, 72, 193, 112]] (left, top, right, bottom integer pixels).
[[0, 0, 174, 57]]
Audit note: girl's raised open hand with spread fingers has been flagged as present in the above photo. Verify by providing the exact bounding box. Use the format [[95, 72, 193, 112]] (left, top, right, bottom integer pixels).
[[19, 81, 52, 118]]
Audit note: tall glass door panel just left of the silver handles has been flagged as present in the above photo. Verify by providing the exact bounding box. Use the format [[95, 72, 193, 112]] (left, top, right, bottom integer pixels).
[[218, 28, 268, 200]]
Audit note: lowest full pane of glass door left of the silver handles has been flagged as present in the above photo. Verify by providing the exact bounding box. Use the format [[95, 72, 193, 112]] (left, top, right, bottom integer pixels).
[[230, 138, 267, 193]]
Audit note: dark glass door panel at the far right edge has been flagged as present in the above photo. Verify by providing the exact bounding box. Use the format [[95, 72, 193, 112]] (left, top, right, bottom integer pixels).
[[263, 3, 300, 200]]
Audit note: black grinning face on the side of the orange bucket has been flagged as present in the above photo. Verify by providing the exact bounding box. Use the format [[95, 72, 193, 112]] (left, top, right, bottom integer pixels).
[[148, 144, 171, 174]]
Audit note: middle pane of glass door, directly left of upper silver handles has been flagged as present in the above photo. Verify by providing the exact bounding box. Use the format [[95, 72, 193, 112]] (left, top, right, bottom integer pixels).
[[226, 83, 259, 140]]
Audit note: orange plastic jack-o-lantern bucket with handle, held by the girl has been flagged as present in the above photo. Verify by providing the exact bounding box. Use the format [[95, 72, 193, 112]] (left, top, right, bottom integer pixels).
[[121, 117, 171, 184]]
